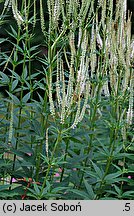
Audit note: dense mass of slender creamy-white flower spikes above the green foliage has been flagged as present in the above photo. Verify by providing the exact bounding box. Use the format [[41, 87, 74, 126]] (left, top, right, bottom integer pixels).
[[1, 0, 134, 142]]
